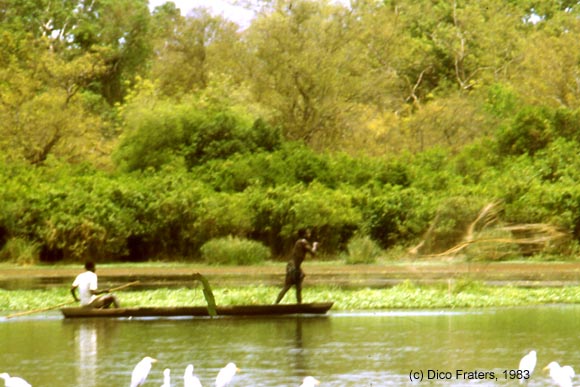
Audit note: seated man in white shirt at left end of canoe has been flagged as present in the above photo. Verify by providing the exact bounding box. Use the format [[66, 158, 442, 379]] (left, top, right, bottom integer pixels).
[[70, 261, 119, 309]]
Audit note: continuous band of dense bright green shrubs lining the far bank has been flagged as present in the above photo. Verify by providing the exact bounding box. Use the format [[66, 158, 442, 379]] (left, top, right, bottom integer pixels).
[[5, 101, 580, 262]]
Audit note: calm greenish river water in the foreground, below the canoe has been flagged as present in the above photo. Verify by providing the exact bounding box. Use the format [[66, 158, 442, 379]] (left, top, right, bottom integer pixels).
[[0, 306, 580, 387]]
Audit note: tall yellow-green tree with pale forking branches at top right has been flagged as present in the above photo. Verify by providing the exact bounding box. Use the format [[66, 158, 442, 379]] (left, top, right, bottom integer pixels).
[[387, 0, 527, 95]]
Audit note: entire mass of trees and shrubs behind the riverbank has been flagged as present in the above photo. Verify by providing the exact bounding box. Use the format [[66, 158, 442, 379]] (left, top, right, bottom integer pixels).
[[0, 0, 580, 264]]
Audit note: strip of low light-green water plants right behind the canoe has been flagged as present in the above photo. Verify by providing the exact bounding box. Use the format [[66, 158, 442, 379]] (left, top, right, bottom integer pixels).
[[5, 281, 580, 312]]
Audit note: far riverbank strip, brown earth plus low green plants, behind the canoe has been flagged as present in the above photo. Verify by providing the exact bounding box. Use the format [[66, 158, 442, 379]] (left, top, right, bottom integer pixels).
[[0, 262, 580, 313]]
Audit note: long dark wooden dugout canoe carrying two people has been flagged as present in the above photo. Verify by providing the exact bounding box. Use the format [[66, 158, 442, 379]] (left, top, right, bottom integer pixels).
[[60, 302, 333, 318]]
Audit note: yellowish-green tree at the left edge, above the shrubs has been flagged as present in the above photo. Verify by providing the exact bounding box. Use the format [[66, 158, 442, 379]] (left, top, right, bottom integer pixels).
[[0, 43, 104, 164]]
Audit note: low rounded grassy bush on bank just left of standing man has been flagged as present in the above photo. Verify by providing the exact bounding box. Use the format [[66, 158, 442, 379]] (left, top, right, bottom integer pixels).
[[201, 236, 270, 265]]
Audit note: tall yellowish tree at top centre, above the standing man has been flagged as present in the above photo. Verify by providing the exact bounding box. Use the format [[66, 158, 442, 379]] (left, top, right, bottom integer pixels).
[[245, 0, 376, 147]]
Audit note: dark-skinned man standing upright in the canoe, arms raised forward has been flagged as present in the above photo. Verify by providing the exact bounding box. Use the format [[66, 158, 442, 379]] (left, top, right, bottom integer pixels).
[[276, 230, 318, 304]]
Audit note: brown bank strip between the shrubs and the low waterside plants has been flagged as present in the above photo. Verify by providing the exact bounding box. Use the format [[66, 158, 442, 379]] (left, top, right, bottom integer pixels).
[[0, 260, 580, 287]]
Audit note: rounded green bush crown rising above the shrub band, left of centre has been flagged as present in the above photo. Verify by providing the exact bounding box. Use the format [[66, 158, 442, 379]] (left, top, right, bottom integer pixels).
[[115, 103, 280, 171]]
